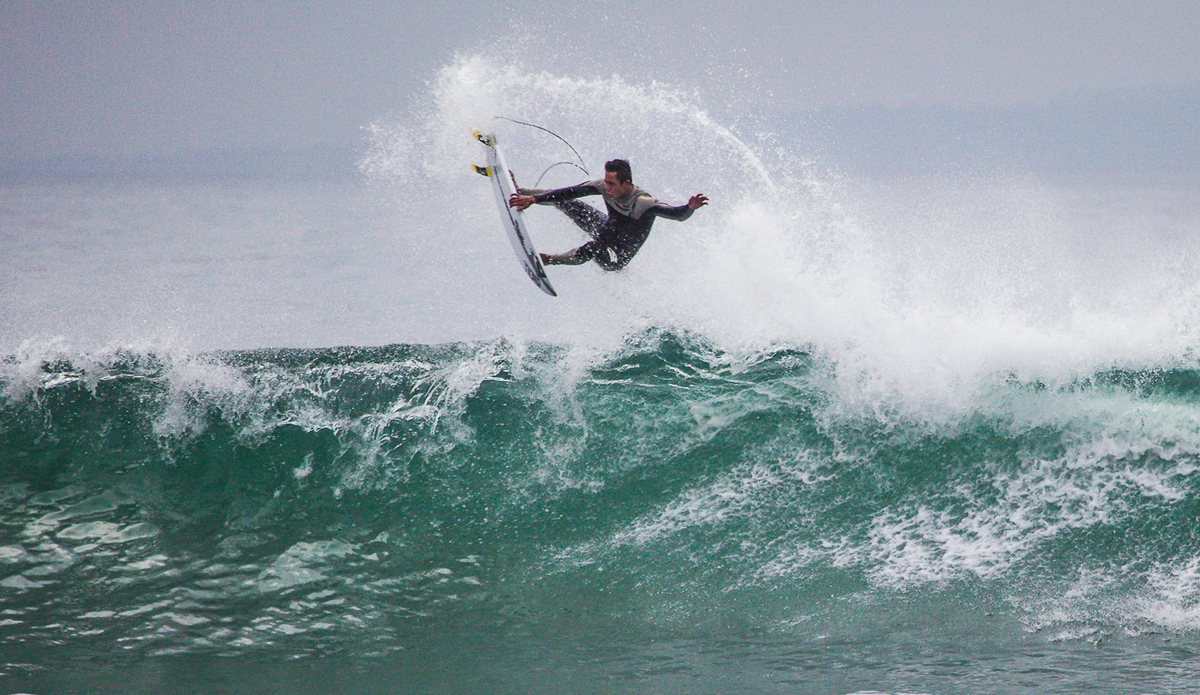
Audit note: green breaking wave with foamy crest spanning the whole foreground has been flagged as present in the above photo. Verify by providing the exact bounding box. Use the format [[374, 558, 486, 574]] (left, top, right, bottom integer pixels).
[[0, 331, 1200, 693]]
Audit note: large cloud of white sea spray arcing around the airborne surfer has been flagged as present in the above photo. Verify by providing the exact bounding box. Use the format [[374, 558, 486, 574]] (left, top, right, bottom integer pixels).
[[361, 54, 1198, 418]]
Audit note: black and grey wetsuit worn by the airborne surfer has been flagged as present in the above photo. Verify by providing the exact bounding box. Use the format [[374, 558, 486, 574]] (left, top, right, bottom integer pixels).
[[526, 179, 694, 270]]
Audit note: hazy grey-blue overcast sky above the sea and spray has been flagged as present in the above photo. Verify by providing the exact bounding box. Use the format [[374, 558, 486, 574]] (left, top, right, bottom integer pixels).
[[0, 0, 1200, 161]]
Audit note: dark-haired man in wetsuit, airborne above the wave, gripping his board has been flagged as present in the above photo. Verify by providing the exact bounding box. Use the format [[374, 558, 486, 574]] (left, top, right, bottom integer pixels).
[[509, 160, 708, 270]]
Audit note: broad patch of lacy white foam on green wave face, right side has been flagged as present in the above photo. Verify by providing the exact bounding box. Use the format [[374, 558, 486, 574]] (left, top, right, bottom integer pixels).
[[862, 415, 1196, 585]]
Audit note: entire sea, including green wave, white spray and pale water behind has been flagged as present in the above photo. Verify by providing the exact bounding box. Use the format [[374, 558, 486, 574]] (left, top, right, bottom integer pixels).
[[0, 55, 1200, 695]]
